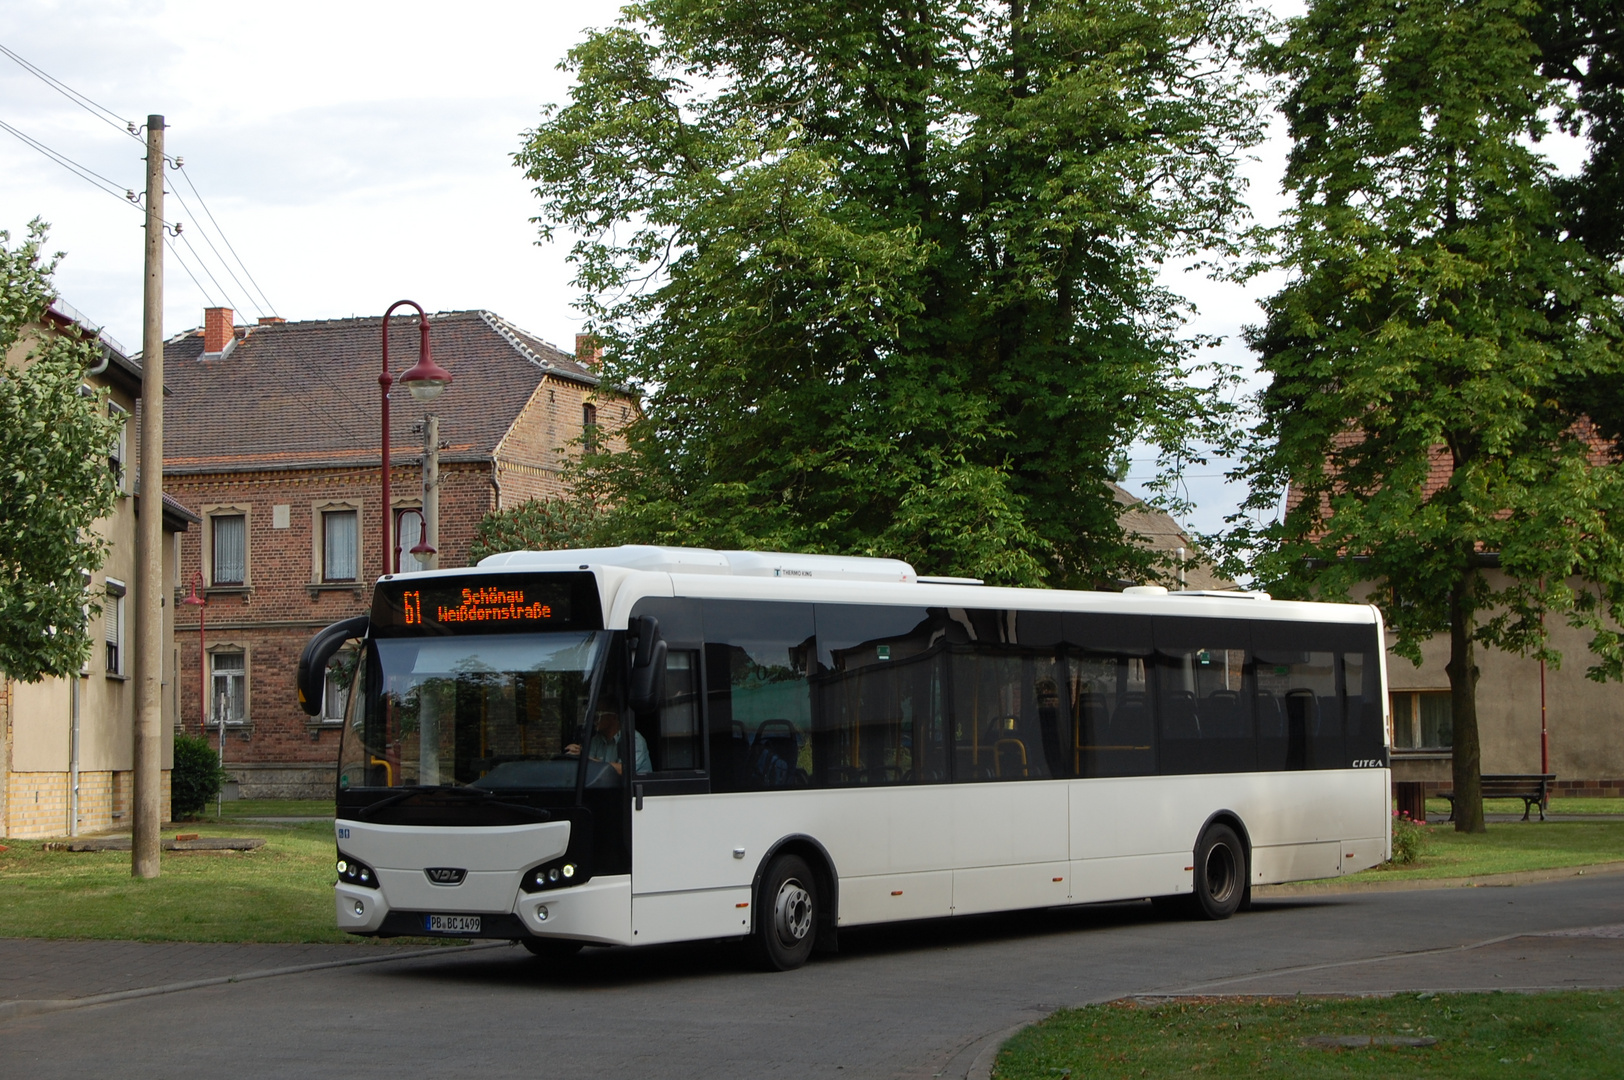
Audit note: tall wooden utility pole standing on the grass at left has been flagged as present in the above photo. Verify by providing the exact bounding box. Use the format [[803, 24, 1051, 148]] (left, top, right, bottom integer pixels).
[[130, 115, 164, 877]]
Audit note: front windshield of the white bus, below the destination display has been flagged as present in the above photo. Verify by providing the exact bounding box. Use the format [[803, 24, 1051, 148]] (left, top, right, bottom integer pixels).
[[338, 630, 609, 789]]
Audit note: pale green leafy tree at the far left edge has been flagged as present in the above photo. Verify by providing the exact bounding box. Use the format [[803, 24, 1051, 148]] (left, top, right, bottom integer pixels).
[[0, 221, 117, 682]]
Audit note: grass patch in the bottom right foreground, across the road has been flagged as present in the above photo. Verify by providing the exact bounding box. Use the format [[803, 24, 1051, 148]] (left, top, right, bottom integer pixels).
[[992, 991, 1624, 1080]]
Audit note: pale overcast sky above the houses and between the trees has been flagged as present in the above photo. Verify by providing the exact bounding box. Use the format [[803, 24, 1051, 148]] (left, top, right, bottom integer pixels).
[[0, 0, 1572, 529]]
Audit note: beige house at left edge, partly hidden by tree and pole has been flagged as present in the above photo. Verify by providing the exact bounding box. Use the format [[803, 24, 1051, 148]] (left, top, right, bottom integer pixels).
[[0, 300, 198, 838]]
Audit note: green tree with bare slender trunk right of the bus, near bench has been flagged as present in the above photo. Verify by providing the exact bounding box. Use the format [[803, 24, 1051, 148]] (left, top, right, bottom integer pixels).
[[1229, 0, 1624, 832]]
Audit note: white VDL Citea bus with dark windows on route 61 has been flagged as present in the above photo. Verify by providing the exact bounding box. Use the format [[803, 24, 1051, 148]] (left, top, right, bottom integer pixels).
[[299, 547, 1390, 970]]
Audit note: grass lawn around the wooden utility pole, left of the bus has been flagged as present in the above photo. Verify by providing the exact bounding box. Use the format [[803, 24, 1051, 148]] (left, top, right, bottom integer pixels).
[[0, 822, 359, 942]]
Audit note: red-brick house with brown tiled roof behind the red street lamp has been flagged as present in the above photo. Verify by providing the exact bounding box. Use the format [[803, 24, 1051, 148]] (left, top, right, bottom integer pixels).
[[164, 309, 637, 797]]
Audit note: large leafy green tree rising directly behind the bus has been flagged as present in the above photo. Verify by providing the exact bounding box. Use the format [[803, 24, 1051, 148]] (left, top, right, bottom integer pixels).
[[516, 0, 1262, 585]]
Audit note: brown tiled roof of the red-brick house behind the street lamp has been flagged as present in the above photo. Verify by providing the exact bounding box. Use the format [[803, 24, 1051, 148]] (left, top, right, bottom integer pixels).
[[164, 312, 598, 474]]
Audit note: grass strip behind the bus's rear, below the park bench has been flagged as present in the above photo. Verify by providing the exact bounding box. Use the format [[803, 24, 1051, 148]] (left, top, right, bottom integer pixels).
[[1343, 819, 1624, 880]]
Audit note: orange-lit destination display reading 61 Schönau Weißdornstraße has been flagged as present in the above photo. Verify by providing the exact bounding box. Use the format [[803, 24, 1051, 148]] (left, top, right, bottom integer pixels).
[[372, 573, 601, 633]]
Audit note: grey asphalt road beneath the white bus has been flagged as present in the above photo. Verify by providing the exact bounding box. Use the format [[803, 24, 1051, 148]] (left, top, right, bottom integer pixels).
[[0, 874, 1624, 1080]]
